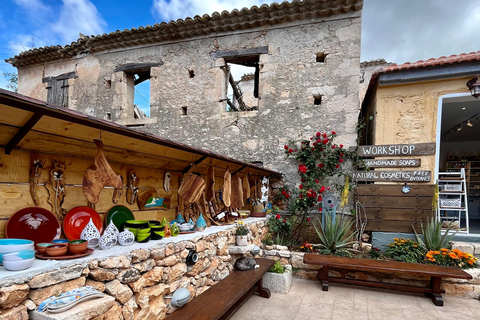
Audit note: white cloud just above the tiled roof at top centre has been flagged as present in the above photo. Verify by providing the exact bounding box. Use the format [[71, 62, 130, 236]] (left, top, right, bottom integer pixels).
[[152, 0, 271, 22]]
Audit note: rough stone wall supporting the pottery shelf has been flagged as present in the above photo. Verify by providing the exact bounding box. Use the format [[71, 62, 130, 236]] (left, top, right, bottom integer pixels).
[[0, 220, 267, 320]]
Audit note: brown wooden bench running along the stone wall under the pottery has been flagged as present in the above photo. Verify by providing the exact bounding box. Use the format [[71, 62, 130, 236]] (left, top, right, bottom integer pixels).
[[167, 258, 275, 320]]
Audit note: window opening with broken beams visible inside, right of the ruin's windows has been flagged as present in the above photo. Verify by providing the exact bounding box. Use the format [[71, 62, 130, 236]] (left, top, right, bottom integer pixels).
[[224, 55, 260, 112]]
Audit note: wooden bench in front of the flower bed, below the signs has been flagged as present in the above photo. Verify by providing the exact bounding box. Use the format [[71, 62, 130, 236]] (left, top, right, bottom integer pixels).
[[303, 253, 472, 306]]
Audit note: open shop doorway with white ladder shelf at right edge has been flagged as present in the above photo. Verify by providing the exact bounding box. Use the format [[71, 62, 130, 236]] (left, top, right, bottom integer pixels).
[[435, 93, 480, 234]]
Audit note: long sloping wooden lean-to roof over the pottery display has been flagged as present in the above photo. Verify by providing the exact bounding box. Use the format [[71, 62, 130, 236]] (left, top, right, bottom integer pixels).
[[0, 89, 281, 178]]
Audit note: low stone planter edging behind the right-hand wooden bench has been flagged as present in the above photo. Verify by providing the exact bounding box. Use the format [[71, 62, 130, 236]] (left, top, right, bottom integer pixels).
[[263, 245, 480, 299]]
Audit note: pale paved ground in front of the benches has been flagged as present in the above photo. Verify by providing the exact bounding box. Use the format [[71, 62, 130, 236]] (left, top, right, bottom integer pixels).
[[231, 278, 480, 320]]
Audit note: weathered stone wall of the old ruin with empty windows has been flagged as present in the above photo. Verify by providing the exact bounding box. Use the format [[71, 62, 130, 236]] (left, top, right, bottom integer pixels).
[[19, 12, 361, 185]]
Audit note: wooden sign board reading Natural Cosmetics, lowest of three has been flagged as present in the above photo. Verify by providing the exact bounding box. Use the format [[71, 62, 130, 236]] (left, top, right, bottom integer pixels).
[[352, 170, 432, 182]]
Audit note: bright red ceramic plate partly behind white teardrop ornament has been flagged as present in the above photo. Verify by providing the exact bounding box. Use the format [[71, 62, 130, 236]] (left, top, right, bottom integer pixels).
[[63, 207, 103, 240]]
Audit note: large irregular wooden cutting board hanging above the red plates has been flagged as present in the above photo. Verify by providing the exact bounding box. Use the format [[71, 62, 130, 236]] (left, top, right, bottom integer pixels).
[[82, 139, 123, 204]]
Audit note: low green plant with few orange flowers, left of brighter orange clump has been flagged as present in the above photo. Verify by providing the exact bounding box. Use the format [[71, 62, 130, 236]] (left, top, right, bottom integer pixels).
[[385, 238, 426, 263]]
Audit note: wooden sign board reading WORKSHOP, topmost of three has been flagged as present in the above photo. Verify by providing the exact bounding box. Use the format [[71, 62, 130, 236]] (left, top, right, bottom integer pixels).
[[357, 142, 436, 157]]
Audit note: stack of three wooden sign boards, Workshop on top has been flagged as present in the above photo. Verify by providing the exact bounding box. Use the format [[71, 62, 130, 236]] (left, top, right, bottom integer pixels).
[[353, 143, 436, 182]]
